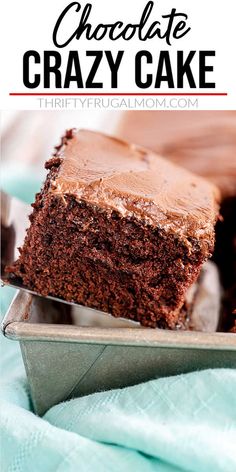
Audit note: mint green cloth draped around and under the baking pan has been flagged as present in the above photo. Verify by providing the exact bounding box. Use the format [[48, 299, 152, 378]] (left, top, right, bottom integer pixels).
[[0, 176, 236, 472]]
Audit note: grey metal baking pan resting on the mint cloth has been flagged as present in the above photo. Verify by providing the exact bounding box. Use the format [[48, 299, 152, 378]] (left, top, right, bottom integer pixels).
[[3, 291, 236, 415]]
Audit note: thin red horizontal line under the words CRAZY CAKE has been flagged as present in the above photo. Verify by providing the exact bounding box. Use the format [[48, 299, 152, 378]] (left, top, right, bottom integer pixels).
[[9, 92, 228, 97]]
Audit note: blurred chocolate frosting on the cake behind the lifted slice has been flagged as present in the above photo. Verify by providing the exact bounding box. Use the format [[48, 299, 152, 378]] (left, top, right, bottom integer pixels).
[[117, 111, 236, 197]]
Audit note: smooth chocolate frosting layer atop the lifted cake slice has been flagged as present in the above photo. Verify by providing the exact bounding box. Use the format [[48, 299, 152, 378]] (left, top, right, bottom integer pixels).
[[50, 130, 219, 246]]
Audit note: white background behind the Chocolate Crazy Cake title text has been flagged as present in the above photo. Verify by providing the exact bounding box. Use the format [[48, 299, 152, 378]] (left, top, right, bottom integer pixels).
[[1, 0, 236, 109]]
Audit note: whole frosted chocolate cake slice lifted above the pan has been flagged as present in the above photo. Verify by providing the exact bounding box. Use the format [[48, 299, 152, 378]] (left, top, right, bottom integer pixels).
[[8, 130, 218, 329]]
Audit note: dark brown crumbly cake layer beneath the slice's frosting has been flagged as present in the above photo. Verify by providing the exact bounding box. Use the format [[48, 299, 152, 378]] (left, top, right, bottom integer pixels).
[[9, 195, 203, 328]]
